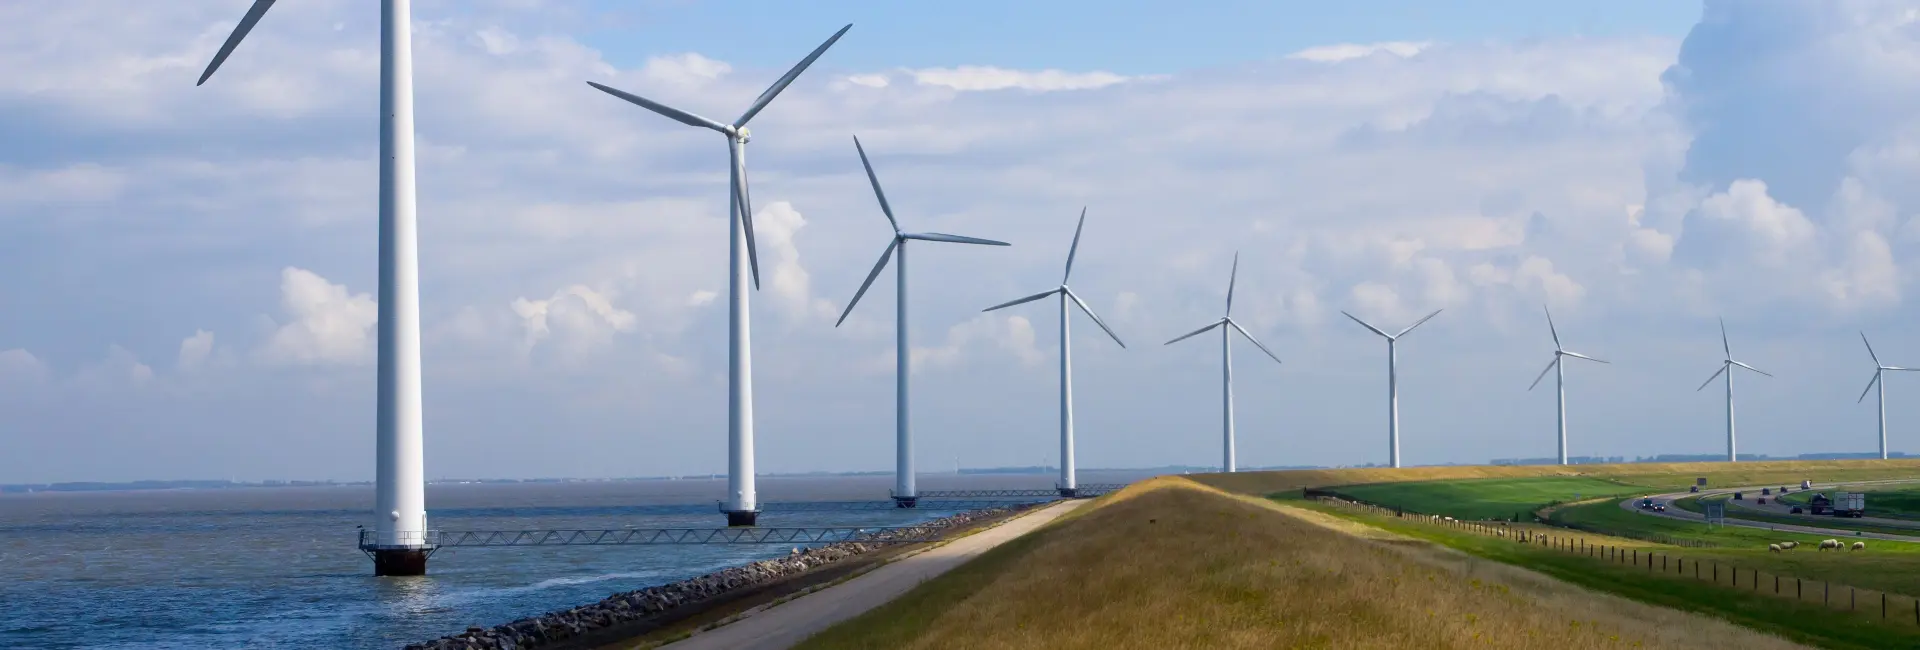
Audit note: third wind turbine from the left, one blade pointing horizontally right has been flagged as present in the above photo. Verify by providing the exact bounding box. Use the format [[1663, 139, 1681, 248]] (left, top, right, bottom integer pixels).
[[833, 136, 1008, 508]]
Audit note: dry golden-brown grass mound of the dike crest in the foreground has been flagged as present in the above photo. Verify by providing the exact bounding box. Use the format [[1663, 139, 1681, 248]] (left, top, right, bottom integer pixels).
[[803, 477, 1801, 650]]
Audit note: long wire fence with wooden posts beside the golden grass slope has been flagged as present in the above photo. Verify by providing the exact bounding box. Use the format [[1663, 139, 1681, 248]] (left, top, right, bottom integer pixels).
[[1313, 493, 1920, 627]]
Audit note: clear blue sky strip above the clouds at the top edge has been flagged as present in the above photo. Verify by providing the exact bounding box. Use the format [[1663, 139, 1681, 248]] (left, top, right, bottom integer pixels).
[[564, 0, 1699, 75]]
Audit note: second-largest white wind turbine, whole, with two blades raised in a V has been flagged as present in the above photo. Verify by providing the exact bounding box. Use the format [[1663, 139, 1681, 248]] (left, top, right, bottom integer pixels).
[[588, 25, 852, 525]]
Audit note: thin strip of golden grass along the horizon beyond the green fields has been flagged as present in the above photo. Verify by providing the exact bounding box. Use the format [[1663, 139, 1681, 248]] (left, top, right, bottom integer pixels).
[[1188, 458, 1920, 495]]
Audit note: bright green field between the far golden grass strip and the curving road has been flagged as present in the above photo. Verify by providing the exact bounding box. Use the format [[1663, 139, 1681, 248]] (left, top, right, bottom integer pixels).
[[1336, 476, 1647, 522]]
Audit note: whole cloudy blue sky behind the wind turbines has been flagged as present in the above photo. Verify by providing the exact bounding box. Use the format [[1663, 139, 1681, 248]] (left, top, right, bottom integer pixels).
[[11, 0, 1920, 483]]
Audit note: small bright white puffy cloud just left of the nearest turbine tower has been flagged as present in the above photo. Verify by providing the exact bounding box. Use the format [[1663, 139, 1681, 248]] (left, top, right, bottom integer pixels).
[[255, 267, 380, 366]]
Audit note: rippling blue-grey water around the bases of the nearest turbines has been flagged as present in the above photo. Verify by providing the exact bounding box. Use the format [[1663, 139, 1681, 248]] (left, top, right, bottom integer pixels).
[[0, 474, 1137, 648]]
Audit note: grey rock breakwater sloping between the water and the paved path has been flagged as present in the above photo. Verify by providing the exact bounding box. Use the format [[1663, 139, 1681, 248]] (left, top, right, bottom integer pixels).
[[405, 504, 1033, 650]]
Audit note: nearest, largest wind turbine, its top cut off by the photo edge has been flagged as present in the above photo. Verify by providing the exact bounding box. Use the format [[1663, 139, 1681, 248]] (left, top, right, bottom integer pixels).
[[194, 0, 434, 575]]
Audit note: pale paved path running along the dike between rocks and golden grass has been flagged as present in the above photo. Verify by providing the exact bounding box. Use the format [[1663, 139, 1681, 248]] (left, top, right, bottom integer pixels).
[[666, 499, 1087, 650]]
